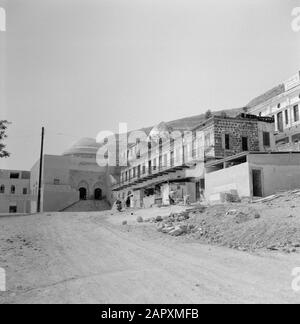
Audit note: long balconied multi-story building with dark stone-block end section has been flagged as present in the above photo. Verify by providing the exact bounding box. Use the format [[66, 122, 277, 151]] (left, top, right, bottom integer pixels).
[[113, 114, 275, 207]]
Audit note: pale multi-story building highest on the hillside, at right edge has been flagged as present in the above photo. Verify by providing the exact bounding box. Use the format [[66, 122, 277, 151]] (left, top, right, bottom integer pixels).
[[247, 72, 300, 151]]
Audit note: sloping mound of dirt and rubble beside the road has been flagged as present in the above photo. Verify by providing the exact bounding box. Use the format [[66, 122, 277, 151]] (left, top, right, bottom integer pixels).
[[157, 191, 300, 253]]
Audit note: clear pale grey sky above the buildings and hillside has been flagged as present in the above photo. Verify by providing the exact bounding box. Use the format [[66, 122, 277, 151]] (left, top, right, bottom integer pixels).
[[0, 0, 300, 170]]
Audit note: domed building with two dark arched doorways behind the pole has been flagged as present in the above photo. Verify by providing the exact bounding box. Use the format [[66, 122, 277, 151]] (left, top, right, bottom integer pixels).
[[30, 138, 116, 212]]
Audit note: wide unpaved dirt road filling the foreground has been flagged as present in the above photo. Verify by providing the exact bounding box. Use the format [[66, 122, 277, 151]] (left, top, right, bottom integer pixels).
[[0, 212, 300, 303]]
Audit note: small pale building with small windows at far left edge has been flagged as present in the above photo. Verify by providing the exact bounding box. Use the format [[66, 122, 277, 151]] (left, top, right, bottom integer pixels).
[[0, 170, 31, 214]]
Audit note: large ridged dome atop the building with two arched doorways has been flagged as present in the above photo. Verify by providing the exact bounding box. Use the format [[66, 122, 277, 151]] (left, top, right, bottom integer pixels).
[[63, 137, 101, 158]]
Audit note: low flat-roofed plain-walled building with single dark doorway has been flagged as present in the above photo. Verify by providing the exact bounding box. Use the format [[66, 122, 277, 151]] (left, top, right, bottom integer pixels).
[[206, 152, 300, 202]]
